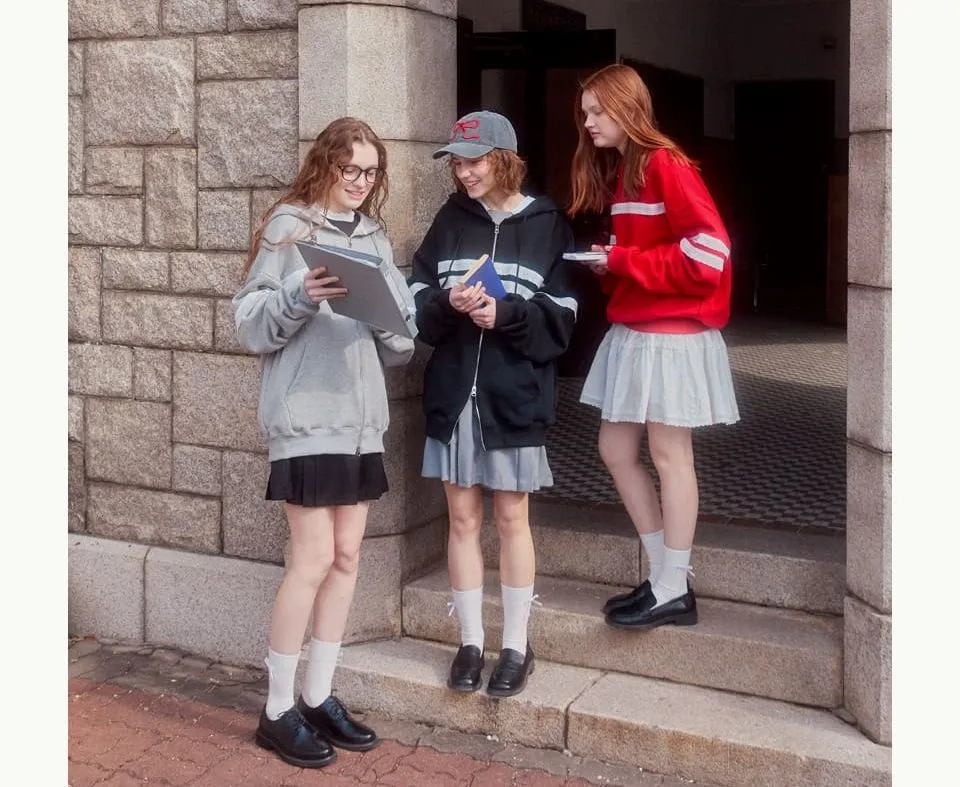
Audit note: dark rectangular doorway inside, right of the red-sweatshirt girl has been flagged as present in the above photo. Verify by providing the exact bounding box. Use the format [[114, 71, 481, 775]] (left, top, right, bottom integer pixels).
[[731, 80, 834, 322]]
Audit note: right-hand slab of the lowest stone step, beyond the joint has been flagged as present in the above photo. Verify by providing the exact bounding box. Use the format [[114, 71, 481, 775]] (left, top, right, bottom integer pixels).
[[567, 673, 892, 787]]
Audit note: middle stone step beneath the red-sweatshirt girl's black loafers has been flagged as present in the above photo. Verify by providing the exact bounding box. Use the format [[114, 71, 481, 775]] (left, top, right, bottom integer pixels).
[[403, 569, 843, 708]]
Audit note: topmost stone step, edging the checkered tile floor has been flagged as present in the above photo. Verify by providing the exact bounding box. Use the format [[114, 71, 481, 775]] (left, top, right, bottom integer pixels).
[[481, 500, 846, 615]]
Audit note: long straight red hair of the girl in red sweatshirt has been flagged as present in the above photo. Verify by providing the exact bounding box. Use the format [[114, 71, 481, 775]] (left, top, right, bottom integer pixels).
[[569, 64, 694, 216]]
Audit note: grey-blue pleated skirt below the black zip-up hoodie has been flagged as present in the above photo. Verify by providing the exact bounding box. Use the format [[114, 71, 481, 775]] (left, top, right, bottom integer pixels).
[[422, 399, 553, 492]]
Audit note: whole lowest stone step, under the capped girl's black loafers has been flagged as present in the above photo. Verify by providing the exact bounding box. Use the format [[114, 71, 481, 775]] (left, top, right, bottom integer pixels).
[[335, 638, 891, 787]]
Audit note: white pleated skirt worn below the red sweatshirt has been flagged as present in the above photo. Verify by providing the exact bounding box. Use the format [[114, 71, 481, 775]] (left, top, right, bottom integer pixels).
[[580, 324, 740, 427]]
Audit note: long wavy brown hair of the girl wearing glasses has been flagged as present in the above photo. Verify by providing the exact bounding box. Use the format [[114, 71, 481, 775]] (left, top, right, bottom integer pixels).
[[244, 117, 390, 275]]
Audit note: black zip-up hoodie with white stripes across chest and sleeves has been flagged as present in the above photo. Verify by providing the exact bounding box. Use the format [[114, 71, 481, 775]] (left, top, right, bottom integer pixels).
[[407, 192, 577, 449]]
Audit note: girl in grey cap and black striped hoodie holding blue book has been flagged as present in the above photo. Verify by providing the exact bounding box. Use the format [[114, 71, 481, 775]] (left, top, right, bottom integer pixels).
[[408, 112, 577, 697]]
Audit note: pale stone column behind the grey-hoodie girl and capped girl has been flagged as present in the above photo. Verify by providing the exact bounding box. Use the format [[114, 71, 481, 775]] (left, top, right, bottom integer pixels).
[[299, 0, 457, 641]]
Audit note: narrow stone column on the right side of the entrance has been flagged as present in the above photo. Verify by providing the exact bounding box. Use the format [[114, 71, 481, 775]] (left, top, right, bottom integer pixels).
[[844, 0, 892, 744]]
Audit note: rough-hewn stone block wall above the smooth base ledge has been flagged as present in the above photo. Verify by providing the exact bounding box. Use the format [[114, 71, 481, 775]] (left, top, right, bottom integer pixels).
[[69, 0, 298, 560]]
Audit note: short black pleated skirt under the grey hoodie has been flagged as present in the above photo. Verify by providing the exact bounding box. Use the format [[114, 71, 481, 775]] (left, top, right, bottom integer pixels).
[[266, 454, 387, 507]]
